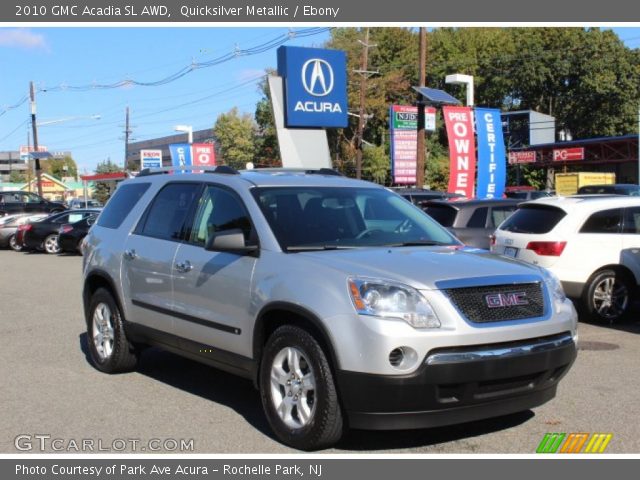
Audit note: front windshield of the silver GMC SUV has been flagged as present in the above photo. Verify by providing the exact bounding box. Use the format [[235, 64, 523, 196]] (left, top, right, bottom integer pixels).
[[254, 187, 459, 251]]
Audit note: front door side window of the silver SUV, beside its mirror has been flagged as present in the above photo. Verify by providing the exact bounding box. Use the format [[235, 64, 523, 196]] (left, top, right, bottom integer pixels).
[[189, 186, 251, 246]]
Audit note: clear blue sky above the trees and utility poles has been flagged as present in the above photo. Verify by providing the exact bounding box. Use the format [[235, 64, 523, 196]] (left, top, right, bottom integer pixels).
[[0, 27, 640, 172]]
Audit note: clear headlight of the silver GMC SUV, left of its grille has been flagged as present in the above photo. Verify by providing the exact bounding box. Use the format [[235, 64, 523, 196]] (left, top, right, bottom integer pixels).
[[348, 277, 440, 328]]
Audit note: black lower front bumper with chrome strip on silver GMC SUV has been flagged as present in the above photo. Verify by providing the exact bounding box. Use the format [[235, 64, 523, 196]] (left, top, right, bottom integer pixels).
[[337, 332, 576, 430]]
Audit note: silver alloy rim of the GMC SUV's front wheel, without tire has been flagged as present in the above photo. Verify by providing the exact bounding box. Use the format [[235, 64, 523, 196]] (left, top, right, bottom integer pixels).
[[271, 347, 316, 429]]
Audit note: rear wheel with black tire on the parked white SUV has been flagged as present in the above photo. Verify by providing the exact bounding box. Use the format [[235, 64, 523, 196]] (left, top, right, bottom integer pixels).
[[582, 268, 632, 323]]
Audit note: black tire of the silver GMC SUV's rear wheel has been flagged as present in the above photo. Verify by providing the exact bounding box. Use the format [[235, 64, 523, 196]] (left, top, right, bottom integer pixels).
[[86, 288, 138, 373]]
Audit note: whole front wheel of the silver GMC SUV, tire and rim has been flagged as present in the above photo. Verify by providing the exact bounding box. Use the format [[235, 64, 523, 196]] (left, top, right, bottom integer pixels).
[[260, 325, 344, 450]]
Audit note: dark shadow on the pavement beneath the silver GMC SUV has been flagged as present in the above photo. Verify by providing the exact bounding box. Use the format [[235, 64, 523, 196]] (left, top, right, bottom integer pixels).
[[79, 333, 534, 453]]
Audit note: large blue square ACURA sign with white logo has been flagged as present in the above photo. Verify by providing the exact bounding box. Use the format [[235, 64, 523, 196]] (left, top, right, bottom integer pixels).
[[278, 47, 348, 127]]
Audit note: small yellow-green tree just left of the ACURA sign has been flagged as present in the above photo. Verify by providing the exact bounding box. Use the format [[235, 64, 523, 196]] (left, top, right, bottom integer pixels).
[[213, 107, 256, 168]]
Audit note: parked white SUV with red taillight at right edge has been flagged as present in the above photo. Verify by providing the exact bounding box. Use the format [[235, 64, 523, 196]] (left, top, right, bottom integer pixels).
[[491, 195, 640, 322]]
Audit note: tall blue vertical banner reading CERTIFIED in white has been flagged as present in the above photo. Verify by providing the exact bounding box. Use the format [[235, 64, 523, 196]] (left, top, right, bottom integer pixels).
[[474, 108, 507, 198]]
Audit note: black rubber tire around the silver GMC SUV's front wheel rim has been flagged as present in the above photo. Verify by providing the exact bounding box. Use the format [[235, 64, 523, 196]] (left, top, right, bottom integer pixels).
[[259, 325, 344, 450]]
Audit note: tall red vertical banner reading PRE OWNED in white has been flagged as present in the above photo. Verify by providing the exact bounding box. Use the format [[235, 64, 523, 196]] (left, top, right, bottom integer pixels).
[[442, 107, 476, 198]]
